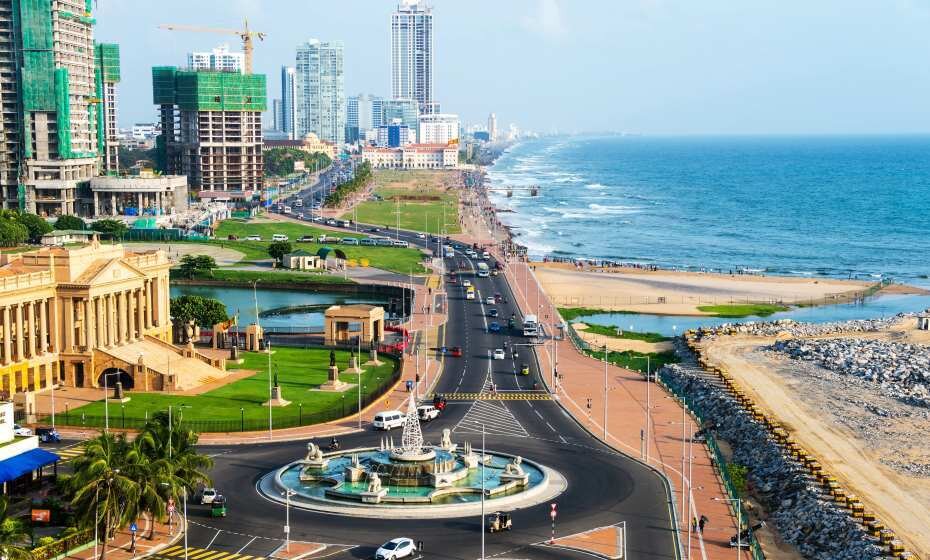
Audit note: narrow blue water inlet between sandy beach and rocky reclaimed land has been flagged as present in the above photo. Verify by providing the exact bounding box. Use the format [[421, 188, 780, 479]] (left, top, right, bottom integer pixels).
[[576, 294, 930, 336]]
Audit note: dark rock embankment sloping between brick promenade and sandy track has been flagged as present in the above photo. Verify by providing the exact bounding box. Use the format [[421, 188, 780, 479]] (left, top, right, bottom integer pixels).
[[664, 365, 883, 560]]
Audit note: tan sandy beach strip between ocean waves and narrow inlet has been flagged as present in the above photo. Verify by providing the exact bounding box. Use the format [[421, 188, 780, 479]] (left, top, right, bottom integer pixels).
[[534, 263, 892, 315]]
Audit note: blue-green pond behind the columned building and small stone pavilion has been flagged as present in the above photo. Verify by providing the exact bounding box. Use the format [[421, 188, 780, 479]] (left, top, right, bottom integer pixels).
[[171, 286, 389, 328]]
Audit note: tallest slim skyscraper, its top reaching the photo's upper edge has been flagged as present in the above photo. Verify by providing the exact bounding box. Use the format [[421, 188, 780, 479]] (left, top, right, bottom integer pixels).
[[391, 0, 438, 113]]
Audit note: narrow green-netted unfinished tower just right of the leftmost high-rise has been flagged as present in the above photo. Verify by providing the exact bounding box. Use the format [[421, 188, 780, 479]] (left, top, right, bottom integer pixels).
[[94, 43, 120, 174]]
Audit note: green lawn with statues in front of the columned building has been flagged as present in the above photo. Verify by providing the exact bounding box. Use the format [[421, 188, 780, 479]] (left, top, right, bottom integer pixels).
[[59, 347, 399, 429]]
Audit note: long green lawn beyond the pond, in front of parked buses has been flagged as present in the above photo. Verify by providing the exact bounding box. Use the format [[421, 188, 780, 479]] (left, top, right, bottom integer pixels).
[[211, 219, 427, 274]]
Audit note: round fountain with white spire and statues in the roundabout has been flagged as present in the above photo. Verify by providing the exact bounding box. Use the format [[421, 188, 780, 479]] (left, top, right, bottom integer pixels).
[[260, 395, 565, 517]]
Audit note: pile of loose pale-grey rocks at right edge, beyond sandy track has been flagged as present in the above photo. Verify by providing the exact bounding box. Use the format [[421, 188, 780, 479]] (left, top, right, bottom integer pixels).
[[767, 338, 930, 408]]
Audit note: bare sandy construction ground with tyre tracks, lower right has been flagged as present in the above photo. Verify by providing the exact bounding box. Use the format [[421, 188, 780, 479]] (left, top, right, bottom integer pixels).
[[704, 333, 930, 554]]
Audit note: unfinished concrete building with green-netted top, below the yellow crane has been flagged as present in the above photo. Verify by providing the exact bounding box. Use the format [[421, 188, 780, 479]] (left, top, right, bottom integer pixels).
[[152, 66, 268, 200]]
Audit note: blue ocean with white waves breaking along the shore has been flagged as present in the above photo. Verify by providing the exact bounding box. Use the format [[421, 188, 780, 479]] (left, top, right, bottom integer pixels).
[[489, 136, 930, 286]]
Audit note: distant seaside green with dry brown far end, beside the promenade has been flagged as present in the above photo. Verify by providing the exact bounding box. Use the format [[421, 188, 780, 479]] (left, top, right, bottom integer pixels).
[[344, 171, 461, 234]]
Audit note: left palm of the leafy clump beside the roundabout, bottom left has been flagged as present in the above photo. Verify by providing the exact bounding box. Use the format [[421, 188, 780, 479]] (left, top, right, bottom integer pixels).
[[69, 433, 141, 560]]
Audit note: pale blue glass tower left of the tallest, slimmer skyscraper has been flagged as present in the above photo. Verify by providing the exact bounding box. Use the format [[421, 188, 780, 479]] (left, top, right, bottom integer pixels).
[[296, 39, 346, 144]]
